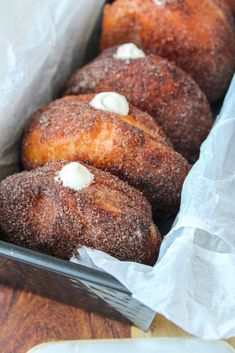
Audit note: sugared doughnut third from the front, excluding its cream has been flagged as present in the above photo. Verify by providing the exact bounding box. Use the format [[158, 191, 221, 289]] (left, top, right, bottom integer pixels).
[[64, 47, 212, 162]]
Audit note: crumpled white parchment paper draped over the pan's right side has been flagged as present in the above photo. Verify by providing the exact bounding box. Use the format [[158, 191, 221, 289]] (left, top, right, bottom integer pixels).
[[71, 78, 235, 339]]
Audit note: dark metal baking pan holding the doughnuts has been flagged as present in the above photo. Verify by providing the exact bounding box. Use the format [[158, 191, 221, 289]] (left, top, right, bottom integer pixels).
[[0, 4, 155, 330]]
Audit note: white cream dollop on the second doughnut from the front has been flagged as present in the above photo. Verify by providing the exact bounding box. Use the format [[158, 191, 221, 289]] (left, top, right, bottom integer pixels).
[[89, 92, 129, 115]]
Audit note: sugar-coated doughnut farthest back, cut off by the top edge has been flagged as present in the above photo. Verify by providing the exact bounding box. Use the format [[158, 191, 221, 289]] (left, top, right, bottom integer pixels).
[[101, 0, 235, 102]]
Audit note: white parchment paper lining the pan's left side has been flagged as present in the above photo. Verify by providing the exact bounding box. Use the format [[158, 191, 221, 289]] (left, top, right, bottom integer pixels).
[[0, 0, 104, 178]]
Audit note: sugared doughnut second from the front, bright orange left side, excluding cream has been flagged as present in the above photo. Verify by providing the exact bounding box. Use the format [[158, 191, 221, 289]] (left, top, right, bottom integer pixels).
[[22, 95, 190, 219]]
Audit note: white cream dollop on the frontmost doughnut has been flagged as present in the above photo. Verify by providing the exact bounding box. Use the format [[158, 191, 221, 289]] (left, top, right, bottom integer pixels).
[[54, 162, 94, 191]]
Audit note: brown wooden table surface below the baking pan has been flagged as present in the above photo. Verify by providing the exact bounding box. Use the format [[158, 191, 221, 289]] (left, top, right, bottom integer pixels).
[[0, 285, 235, 353]]
